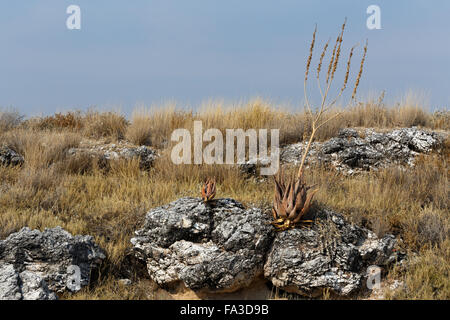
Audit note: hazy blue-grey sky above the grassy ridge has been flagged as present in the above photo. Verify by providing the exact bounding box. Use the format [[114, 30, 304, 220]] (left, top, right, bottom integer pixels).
[[0, 0, 450, 115]]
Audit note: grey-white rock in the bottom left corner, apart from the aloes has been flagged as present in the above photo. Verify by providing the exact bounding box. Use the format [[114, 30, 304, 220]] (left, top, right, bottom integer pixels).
[[0, 227, 105, 300]]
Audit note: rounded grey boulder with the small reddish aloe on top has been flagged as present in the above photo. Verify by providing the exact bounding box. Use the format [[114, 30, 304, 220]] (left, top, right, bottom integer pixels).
[[131, 198, 274, 293]]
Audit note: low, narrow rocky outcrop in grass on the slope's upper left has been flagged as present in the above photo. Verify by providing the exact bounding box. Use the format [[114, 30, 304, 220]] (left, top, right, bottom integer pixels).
[[67, 142, 158, 170]]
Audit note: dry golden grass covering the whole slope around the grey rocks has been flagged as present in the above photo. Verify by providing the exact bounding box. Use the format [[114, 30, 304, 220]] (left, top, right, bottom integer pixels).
[[0, 100, 450, 299]]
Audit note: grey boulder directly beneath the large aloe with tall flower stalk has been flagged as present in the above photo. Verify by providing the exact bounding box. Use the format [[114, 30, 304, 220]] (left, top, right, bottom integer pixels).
[[264, 209, 397, 297]]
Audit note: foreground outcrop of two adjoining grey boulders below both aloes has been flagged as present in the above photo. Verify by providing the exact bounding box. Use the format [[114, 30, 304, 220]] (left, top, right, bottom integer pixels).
[[131, 198, 398, 297]]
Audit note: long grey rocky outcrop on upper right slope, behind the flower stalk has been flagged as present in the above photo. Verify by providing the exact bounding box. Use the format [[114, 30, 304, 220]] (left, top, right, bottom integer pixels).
[[280, 128, 444, 174]]
